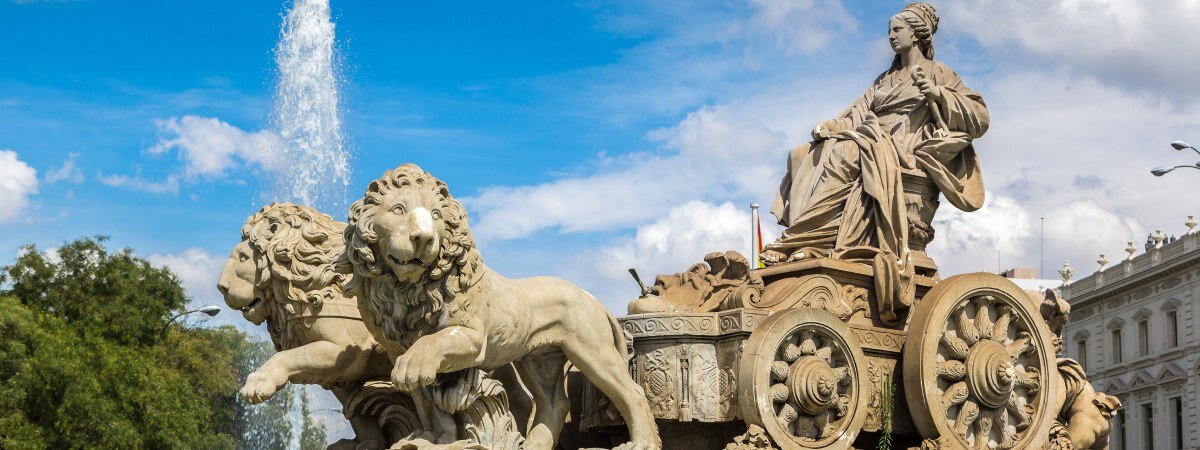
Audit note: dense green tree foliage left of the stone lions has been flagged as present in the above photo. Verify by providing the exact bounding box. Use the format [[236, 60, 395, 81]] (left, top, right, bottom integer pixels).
[[0, 238, 324, 449]]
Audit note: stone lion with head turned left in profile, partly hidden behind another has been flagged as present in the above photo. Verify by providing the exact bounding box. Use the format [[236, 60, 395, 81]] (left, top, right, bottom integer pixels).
[[217, 203, 398, 450]]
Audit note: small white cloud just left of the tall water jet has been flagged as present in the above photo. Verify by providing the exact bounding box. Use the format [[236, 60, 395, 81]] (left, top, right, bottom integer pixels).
[[146, 115, 282, 179]]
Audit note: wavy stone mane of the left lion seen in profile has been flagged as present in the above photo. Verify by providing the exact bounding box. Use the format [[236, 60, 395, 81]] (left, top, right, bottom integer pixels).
[[241, 203, 349, 350]]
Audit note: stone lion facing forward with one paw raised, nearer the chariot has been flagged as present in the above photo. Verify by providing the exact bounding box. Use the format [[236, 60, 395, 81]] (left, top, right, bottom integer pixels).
[[346, 164, 661, 450]]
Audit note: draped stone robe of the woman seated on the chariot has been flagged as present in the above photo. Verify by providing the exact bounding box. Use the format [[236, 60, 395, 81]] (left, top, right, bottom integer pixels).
[[768, 60, 989, 258]]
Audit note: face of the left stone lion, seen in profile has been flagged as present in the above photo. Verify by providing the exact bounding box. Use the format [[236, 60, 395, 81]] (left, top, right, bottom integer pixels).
[[217, 240, 268, 325]]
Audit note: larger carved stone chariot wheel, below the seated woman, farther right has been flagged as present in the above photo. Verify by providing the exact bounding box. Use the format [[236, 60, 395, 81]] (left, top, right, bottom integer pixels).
[[902, 274, 1057, 449]]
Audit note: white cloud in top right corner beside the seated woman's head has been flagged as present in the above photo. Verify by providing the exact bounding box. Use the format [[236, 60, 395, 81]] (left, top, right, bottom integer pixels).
[[942, 0, 1200, 97]]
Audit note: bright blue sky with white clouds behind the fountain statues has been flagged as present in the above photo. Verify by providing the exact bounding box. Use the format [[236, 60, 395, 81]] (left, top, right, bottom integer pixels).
[[0, 0, 1200, 319]]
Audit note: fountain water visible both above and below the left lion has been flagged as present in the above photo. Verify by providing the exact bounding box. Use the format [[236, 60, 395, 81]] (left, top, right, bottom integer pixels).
[[241, 0, 350, 450]]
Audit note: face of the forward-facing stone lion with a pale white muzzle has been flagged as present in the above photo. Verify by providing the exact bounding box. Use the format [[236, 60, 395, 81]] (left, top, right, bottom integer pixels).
[[371, 183, 442, 282]]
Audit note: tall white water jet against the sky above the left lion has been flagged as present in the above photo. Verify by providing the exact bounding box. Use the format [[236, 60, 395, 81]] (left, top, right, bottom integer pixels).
[[271, 0, 350, 211]]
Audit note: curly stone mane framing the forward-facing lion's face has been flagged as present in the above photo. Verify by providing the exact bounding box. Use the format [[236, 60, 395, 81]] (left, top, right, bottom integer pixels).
[[346, 164, 485, 350]]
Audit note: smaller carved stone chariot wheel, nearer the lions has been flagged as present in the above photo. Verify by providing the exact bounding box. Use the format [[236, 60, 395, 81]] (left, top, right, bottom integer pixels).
[[738, 308, 866, 450]]
